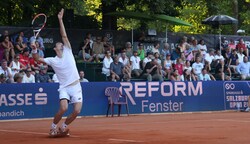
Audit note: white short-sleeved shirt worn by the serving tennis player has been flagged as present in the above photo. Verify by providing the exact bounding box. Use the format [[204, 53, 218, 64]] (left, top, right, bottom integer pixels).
[[44, 46, 80, 89]]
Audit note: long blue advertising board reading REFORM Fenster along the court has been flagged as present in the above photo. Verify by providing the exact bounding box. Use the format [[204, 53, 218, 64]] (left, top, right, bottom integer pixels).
[[0, 81, 250, 120]]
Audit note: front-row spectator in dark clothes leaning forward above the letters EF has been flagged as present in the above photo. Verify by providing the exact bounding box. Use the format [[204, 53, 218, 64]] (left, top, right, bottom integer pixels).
[[140, 60, 163, 81]]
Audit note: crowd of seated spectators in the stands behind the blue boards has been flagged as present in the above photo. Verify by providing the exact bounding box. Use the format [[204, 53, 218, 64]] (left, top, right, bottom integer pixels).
[[0, 31, 250, 83]]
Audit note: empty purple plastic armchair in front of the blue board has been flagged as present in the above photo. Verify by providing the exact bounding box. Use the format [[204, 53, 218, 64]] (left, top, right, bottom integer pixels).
[[105, 87, 129, 117]]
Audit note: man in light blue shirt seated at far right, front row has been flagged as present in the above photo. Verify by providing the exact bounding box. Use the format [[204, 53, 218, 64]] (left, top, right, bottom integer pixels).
[[236, 56, 250, 80]]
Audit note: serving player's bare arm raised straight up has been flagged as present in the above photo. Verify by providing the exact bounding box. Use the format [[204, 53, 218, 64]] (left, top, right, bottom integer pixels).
[[58, 9, 71, 48]]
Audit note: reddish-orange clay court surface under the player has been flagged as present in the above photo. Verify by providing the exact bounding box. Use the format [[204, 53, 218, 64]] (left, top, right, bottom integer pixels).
[[0, 112, 250, 144]]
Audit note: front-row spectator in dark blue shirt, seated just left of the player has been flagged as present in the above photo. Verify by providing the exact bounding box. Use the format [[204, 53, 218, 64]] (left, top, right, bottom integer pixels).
[[35, 66, 52, 83]]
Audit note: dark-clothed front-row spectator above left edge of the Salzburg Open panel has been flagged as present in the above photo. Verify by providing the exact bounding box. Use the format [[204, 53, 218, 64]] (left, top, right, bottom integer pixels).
[[215, 59, 231, 81]]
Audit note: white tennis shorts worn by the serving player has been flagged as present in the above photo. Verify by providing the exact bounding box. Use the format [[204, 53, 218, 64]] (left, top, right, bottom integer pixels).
[[58, 82, 82, 103]]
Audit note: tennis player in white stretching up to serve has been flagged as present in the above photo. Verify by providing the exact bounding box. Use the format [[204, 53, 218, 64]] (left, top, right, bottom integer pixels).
[[32, 9, 82, 137]]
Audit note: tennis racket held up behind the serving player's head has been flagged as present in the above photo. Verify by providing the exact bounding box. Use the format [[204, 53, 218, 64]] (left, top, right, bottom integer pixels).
[[31, 13, 47, 39]]
